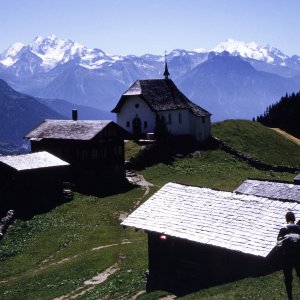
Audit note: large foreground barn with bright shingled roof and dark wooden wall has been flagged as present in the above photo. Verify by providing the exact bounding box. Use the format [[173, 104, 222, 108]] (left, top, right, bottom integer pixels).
[[122, 183, 300, 294]]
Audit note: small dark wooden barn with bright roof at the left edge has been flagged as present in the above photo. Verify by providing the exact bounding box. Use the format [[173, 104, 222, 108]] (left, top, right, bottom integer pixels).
[[0, 151, 69, 217]]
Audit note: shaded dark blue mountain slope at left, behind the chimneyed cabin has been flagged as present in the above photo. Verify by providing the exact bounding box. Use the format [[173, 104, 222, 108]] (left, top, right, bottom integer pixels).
[[0, 79, 110, 154]]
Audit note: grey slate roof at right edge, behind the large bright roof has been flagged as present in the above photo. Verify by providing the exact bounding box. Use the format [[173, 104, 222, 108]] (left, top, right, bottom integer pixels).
[[234, 179, 300, 203]]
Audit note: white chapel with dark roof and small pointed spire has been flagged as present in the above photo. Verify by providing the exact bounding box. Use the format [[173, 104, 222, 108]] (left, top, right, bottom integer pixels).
[[112, 69, 211, 142]]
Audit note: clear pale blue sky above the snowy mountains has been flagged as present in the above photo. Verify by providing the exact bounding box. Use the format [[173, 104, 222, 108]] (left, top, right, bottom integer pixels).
[[0, 0, 300, 55]]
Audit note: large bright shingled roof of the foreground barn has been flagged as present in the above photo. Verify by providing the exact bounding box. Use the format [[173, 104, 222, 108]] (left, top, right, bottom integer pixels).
[[122, 183, 300, 257]]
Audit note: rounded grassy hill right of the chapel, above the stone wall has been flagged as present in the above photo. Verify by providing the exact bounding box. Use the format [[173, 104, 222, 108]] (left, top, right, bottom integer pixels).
[[212, 120, 300, 168]]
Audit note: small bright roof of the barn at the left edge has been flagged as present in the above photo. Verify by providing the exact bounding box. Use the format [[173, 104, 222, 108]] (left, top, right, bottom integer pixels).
[[0, 151, 69, 171]]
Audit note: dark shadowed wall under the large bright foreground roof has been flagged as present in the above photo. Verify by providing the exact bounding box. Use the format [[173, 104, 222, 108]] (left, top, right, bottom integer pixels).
[[146, 231, 278, 295]]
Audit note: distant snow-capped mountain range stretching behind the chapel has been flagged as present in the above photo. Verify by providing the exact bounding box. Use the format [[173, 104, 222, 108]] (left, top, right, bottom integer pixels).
[[0, 35, 300, 121]]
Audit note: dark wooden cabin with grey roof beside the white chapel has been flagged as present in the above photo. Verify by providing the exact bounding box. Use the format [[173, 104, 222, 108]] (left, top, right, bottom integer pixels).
[[26, 120, 129, 193]]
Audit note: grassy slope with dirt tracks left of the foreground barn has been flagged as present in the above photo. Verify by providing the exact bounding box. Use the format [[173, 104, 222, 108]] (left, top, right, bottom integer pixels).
[[0, 188, 147, 299]]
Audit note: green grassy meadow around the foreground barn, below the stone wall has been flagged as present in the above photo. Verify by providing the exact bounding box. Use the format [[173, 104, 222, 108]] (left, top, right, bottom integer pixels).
[[0, 120, 300, 300]]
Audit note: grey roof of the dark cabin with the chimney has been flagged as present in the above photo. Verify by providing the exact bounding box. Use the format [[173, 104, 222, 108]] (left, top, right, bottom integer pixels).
[[26, 120, 125, 140]]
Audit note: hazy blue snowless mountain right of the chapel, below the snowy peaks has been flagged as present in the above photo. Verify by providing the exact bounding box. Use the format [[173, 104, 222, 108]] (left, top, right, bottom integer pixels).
[[178, 52, 300, 120]]
